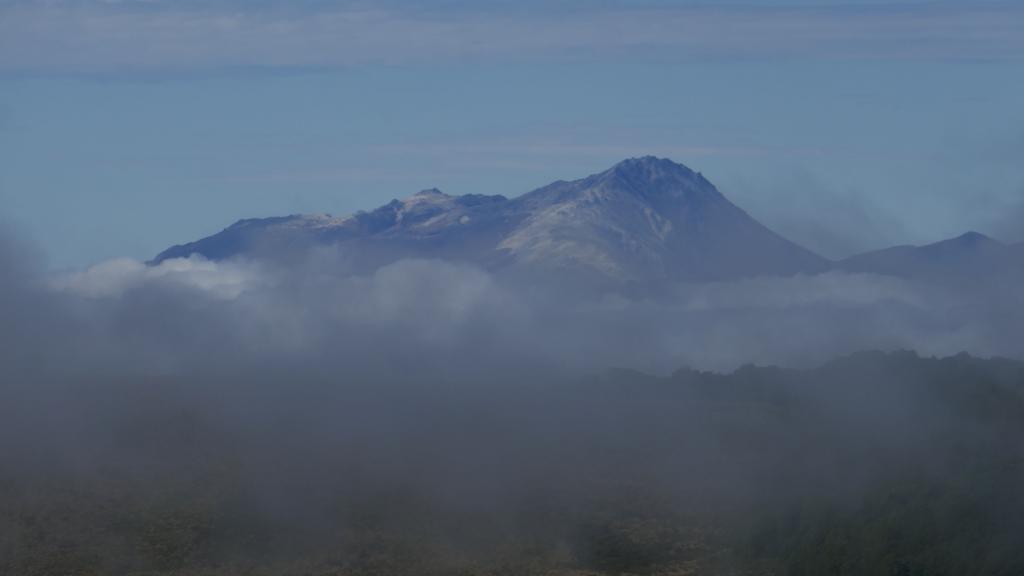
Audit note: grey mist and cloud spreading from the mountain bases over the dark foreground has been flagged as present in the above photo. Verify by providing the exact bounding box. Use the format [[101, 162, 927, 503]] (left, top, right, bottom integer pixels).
[[6, 223, 1024, 574]]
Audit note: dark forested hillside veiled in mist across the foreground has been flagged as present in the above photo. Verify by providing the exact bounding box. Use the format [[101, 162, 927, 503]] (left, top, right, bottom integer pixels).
[[0, 353, 1024, 576]]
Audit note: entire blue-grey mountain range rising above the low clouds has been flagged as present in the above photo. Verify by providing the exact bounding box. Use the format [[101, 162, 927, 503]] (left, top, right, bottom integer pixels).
[[152, 157, 1024, 287]]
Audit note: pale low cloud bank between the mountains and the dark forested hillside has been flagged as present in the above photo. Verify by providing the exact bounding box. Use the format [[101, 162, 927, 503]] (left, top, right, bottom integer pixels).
[[44, 238, 1024, 373]]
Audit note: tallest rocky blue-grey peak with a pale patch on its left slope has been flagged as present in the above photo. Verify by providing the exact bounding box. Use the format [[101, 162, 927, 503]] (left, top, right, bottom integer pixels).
[[491, 157, 827, 281]]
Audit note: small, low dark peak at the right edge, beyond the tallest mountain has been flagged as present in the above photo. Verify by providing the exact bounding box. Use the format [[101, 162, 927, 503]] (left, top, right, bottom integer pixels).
[[836, 232, 1024, 283]]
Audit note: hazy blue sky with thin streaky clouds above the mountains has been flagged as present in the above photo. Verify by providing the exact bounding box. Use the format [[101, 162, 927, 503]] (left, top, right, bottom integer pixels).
[[0, 0, 1024, 268]]
